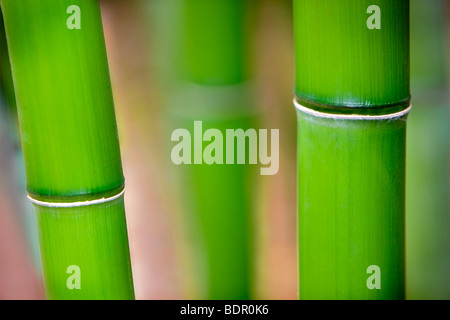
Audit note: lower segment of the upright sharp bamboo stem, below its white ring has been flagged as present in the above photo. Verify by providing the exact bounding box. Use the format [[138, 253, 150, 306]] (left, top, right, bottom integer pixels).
[[298, 111, 406, 299]]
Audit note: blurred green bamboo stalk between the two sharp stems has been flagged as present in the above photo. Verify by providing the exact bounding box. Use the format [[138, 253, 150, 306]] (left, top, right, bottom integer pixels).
[[160, 0, 256, 299]]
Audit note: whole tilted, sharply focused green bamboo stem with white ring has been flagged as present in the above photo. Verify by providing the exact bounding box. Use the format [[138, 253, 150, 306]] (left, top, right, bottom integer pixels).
[[2, 0, 134, 299]]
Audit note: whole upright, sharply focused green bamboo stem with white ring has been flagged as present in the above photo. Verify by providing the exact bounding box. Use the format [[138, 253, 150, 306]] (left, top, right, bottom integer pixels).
[[294, 0, 410, 299]]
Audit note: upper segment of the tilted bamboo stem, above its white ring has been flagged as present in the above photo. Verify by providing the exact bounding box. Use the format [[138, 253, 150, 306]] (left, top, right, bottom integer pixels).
[[2, 0, 123, 201]]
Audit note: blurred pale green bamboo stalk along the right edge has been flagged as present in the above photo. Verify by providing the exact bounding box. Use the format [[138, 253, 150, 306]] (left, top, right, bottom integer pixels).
[[406, 0, 450, 299]]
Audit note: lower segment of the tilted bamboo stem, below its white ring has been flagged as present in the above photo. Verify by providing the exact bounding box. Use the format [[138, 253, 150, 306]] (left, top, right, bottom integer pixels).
[[35, 198, 134, 300]]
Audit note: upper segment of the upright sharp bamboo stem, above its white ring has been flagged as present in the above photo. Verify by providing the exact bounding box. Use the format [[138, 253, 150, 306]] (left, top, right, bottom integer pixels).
[[294, 0, 409, 107]]
